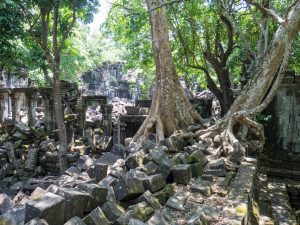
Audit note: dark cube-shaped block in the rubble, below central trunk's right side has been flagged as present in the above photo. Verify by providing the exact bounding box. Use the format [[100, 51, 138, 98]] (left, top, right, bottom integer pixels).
[[172, 164, 192, 185]]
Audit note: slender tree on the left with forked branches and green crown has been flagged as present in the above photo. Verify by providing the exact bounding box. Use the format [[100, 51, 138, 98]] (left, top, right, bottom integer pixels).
[[19, 0, 98, 172]]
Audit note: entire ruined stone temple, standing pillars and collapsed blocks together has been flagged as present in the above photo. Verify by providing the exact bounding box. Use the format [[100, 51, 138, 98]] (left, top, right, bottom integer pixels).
[[0, 68, 299, 225]]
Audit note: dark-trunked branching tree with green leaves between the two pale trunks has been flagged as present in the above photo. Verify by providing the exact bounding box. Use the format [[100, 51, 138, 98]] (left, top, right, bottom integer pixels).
[[170, 1, 234, 116]]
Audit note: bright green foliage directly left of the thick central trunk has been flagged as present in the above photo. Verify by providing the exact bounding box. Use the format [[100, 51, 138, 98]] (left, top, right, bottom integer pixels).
[[102, 0, 155, 91]]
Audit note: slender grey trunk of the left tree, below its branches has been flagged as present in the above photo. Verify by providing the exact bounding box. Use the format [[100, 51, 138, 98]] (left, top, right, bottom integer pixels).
[[52, 70, 68, 173]]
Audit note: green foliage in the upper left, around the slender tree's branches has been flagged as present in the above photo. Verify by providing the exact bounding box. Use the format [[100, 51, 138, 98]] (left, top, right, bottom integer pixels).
[[0, 0, 101, 85]]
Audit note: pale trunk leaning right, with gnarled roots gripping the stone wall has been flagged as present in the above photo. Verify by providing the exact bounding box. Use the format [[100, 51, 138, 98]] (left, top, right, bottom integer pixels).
[[196, 1, 300, 158]]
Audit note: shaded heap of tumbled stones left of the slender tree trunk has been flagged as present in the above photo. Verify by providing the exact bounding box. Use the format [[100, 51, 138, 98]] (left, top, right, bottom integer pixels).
[[0, 123, 80, 192]]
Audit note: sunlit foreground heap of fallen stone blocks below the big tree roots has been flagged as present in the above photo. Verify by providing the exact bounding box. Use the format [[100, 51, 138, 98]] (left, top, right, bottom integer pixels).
[[0, 125, 255, 225]]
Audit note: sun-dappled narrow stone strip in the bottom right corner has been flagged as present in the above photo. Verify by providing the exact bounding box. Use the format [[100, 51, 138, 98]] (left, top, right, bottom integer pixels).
[[268, 181, 296, 225]]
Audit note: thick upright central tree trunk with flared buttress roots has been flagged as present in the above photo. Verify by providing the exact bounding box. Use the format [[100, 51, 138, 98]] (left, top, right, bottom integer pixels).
[[133, 0, 200, 140]]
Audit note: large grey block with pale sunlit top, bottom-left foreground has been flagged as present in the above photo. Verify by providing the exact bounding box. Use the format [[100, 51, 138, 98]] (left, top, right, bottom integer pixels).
[[25, 193, 65, 225]]
